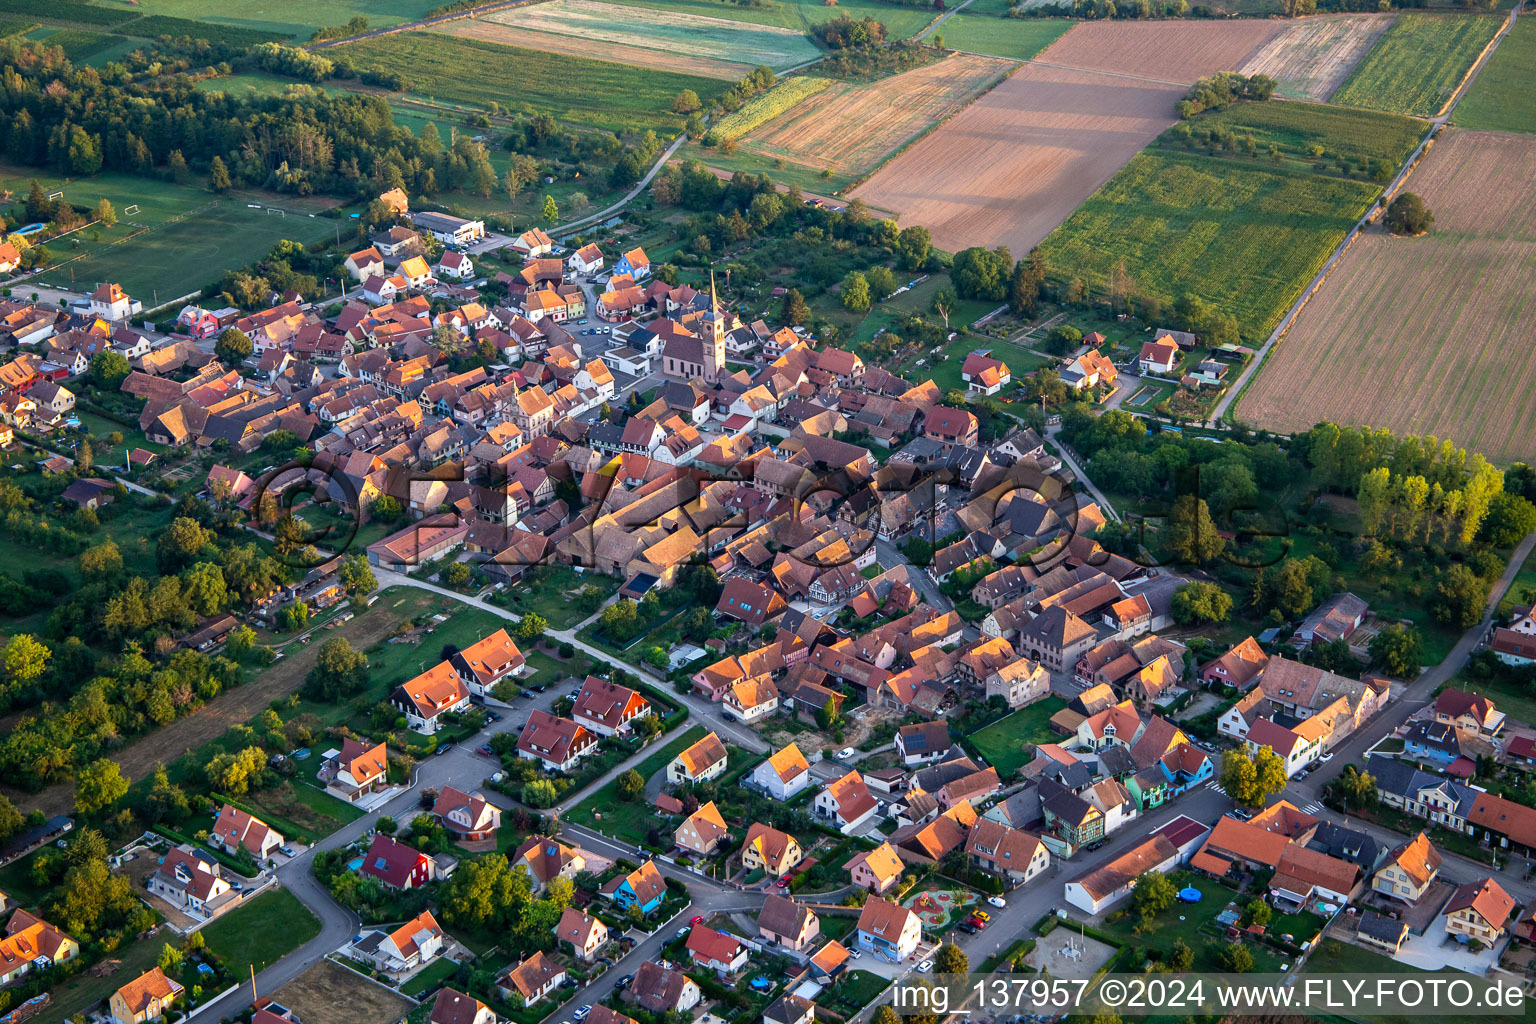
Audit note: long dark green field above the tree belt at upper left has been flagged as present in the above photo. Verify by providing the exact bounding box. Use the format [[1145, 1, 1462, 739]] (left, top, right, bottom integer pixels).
[[338, 32, 728, 132]]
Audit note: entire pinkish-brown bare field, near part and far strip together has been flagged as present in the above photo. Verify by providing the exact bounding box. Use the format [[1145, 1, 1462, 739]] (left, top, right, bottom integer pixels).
[[852, 20, 1278, 255]]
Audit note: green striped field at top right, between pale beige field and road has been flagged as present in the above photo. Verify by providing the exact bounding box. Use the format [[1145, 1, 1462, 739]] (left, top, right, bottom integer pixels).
[[1332, 14, 1504, 117]]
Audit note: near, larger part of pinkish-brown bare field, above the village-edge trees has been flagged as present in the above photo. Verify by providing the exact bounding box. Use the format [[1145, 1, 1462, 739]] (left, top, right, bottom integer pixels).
[[852, 63, 1198, 253]]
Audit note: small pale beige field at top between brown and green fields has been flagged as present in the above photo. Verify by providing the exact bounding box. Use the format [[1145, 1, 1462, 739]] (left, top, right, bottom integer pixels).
[[1238, 14, 1393, 100]]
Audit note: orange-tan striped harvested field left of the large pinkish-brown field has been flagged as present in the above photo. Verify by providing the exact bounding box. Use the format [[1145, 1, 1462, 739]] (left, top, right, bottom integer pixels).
[[743, 54, 1014, 175]]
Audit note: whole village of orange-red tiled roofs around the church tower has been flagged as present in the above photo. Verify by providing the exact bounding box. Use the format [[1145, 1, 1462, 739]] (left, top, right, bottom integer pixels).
[[0, 168, 1536, 1024]]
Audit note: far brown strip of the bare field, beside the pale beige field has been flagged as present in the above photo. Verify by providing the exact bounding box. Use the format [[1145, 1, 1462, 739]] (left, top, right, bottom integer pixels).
[[1035, 20, 1281, 86]]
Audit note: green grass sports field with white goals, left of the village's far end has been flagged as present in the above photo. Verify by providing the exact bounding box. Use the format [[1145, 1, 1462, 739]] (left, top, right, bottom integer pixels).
[[0, 167, 338, 309]]
